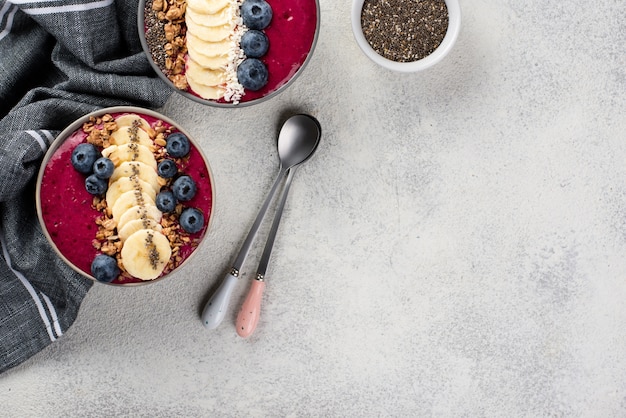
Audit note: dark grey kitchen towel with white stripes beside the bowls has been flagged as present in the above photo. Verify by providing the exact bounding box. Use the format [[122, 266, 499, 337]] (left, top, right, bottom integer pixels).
[[0, 0, 170, 372]]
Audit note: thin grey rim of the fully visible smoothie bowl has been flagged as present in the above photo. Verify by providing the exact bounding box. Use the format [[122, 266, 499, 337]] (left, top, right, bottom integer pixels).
[[35, 106, 215, 287]]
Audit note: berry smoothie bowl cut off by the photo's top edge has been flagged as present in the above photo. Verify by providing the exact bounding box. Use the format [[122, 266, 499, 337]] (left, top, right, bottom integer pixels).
[[138, 0, 320, 107]]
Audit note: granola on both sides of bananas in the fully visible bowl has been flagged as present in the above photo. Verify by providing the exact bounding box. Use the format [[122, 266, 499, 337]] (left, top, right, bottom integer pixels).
[[82, 115, 195, 279]]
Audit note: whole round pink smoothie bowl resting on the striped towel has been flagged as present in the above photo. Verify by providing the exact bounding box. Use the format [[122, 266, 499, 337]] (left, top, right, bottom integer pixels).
[[36, 107, 214, 285]]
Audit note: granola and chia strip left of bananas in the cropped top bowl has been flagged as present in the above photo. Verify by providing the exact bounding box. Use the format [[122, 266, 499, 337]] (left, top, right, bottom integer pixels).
[[145, 0, 188, 90]]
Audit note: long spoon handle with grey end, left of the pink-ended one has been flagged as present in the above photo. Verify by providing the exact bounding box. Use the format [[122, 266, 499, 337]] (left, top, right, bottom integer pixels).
[[201, 166, 287, 329]]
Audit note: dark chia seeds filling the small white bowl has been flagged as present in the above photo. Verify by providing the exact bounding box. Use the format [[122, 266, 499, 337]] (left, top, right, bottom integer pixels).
[[361, 0, 448, 62]]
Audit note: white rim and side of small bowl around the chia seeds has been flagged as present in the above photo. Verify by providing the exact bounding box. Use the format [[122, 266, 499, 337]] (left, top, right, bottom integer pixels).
[[352, 0, 461, 73]]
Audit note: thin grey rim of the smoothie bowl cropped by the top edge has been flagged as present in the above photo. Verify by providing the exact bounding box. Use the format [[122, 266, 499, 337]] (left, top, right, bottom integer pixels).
[[137, 0, 321, 109]]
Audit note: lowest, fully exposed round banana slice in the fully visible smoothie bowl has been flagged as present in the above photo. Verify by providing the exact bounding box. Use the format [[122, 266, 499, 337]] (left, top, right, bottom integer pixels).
[[121, 229, 172, 280]]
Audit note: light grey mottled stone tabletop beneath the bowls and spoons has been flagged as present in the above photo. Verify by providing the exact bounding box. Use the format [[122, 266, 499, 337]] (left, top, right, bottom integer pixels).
[[0, 0, 626, 417]]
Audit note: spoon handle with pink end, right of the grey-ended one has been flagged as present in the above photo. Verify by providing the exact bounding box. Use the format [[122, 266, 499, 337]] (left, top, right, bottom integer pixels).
[[236, 167, 296, 338]]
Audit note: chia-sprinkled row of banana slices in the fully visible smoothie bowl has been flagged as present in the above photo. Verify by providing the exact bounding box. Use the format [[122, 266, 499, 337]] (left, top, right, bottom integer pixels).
[[102, 114, 172, 280]]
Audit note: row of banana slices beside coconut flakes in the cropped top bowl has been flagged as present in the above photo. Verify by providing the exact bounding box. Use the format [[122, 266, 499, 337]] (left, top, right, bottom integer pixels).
[[185, 0, 241, 100]]
